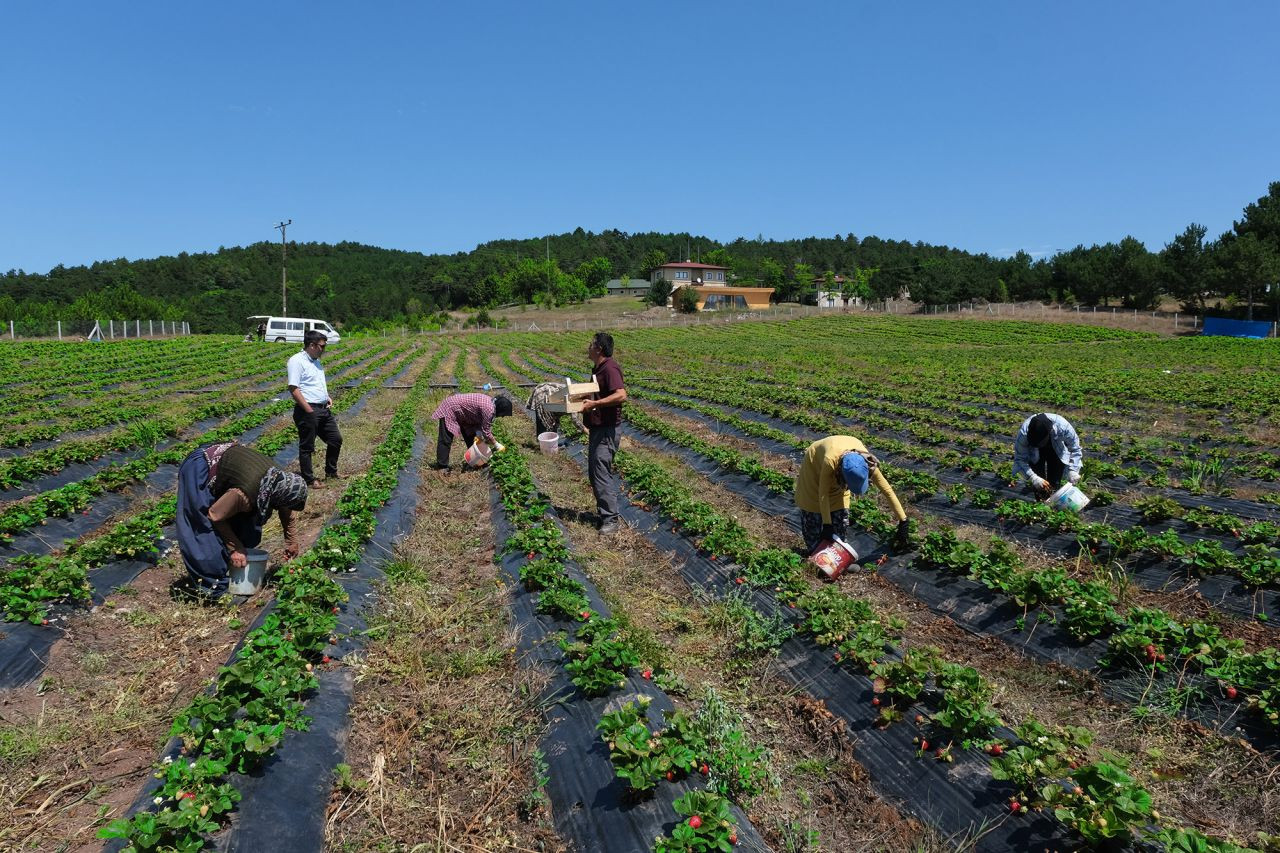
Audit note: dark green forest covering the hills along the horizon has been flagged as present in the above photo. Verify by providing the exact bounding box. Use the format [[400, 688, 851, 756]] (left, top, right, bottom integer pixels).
[[0, 182, 1280, 332]]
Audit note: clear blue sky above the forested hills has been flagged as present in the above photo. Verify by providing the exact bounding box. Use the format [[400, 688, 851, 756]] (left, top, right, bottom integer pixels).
[[0, 0, 1280, 272]]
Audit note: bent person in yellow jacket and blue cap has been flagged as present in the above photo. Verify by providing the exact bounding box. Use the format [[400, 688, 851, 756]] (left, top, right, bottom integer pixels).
[[795, 435, 908, 553]]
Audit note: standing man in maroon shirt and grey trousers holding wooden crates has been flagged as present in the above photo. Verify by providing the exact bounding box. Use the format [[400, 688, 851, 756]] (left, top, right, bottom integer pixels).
[[582, 332, 627, 534]]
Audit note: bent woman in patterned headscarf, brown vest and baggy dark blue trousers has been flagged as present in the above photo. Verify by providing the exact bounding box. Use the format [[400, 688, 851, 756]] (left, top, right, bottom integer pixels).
[[177, 442, 307, 596]]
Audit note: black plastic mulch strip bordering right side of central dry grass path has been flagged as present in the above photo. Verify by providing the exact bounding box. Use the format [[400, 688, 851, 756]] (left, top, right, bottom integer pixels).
[[490, 466, 769, 853]]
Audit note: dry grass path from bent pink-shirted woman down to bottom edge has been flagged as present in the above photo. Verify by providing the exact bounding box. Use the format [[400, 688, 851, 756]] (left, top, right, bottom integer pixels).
[[326, 386, 563, 850]]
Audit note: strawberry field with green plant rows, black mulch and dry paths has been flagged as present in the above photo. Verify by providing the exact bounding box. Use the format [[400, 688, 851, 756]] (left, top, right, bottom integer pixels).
[[0, 316, 1280, 850]]
